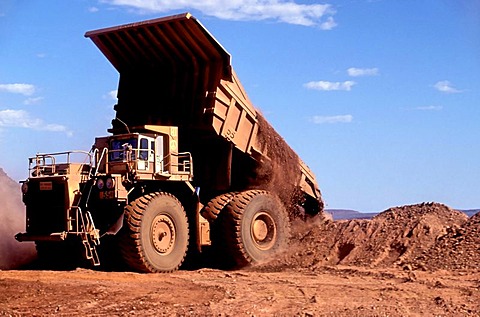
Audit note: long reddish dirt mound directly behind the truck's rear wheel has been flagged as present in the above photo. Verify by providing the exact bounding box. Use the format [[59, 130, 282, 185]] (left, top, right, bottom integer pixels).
[[259, 203, 470, 270]]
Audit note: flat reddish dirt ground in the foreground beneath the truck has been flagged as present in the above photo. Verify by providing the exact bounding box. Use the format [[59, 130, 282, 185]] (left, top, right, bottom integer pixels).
[[0, 266, 480, 316]]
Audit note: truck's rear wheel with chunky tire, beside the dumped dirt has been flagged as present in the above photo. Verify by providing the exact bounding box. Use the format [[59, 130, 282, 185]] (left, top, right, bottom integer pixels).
[[222, 190, 290, 267]]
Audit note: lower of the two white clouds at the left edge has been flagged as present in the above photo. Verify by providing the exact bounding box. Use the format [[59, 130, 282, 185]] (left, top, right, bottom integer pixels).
[[0, 109, 72, 136]]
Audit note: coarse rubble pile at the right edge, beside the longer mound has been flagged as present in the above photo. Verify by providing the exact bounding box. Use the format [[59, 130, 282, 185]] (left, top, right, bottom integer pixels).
[[415, 213, 480, 271]]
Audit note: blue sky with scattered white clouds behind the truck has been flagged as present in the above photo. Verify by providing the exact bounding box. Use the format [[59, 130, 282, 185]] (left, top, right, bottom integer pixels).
[[0, 0, 480, 211]]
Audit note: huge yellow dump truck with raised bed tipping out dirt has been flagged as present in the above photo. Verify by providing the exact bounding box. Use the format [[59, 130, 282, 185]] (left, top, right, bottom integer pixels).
[[16, 13, 323, 272]]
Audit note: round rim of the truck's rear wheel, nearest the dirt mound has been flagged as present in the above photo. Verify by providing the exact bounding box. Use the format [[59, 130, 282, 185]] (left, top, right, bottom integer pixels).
[[250, 212, 277, 250]]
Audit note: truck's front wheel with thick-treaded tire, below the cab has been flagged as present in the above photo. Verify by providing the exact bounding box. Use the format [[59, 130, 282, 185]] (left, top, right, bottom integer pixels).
[[119, 192, 189, 273]]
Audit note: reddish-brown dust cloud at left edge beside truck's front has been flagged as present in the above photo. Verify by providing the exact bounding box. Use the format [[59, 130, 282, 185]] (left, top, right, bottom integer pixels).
[[0, 168, 36, 270]]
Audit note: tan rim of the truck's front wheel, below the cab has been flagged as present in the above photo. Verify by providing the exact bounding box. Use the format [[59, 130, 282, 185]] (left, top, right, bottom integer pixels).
[[151, 215, 176, 255]]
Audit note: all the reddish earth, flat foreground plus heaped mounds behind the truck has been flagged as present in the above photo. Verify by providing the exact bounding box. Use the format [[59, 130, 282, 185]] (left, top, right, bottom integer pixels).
[[0, 168, 480, 316]]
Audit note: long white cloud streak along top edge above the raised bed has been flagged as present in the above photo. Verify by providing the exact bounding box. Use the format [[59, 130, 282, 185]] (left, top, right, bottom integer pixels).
[[101, 0, 336, 30]]
